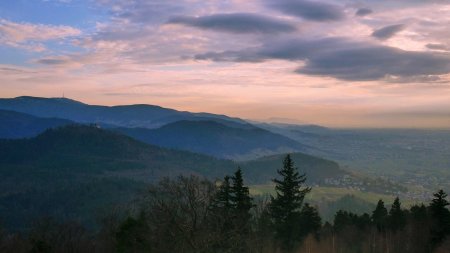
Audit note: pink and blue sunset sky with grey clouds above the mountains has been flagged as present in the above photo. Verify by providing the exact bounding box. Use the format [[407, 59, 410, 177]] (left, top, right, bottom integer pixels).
[[0, 0, 450, 128]]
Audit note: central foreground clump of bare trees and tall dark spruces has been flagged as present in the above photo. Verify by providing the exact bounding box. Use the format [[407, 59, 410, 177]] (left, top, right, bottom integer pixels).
[[112, 161, 321, 252]]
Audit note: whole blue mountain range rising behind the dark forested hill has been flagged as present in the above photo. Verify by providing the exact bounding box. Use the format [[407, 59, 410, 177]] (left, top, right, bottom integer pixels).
[[0, 97, 309, 160]]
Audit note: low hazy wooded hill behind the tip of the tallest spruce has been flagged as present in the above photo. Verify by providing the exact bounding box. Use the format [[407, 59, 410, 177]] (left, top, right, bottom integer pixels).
[[239, 153, 350, 184]]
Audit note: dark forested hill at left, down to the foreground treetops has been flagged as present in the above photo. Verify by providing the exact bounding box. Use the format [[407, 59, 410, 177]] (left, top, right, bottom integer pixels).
[[0, 125, 236, 228]]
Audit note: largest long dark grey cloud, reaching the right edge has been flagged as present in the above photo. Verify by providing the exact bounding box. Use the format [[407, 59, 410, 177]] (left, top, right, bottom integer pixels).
[[196, 38, 450, 82]]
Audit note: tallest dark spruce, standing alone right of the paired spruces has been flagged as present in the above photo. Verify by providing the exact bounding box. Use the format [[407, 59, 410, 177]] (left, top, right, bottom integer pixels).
[[270, 155, 311, 251]]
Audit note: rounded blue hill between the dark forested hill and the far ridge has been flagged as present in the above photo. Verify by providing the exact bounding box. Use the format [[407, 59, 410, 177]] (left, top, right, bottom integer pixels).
[[117, 121, 305, 159]]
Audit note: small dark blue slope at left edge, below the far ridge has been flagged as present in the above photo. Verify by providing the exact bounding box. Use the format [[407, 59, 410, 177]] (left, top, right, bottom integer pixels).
[[0, 110, 73, 139]]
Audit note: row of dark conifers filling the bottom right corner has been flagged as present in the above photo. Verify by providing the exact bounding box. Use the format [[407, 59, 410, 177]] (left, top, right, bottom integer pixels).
[[318, 190, 450, 253]]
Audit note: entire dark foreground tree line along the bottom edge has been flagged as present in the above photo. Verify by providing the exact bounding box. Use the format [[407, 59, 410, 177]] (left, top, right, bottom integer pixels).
[[0, 155, 450, 253]]
